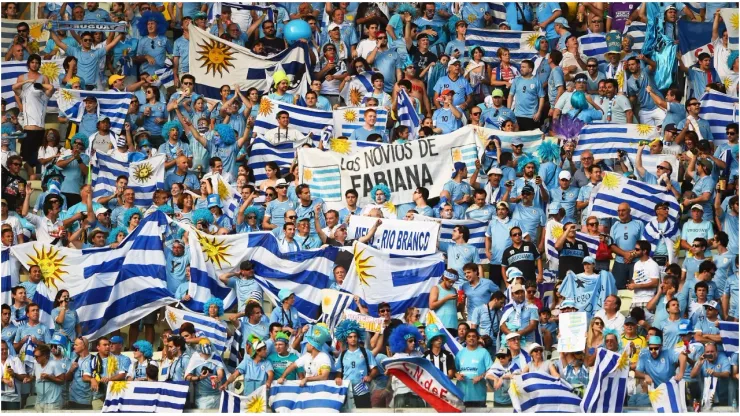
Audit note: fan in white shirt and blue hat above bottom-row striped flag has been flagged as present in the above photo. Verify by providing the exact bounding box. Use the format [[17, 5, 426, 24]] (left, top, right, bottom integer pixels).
[[277, 324, 331, 387]]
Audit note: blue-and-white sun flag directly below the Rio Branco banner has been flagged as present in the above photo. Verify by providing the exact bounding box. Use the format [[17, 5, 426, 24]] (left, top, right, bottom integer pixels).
[[342, 242, 445, 316]]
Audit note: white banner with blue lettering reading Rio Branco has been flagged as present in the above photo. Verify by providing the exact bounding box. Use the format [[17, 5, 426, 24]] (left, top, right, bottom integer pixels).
[[347, 215, 439, 256]]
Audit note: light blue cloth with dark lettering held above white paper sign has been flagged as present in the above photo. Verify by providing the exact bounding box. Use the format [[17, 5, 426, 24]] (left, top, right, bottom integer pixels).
[[560, 270, 617, 316]]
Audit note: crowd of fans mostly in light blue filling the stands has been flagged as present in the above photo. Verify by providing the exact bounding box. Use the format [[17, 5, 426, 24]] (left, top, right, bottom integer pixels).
[[0, 2, 740, 411]]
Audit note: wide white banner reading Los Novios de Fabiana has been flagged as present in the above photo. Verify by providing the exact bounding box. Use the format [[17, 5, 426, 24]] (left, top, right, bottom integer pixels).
[[298, 126, 478, 209]]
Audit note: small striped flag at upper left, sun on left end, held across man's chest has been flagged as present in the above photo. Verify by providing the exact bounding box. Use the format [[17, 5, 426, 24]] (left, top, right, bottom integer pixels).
[[57, 89, 134, 134]]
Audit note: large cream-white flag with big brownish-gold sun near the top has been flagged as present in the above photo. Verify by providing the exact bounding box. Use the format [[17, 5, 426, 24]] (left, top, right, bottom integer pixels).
[[189, 26, 310, 98]]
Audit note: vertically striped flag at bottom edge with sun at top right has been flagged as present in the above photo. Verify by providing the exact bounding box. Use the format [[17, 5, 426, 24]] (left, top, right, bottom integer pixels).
[[581, 348, 630, 413]]
